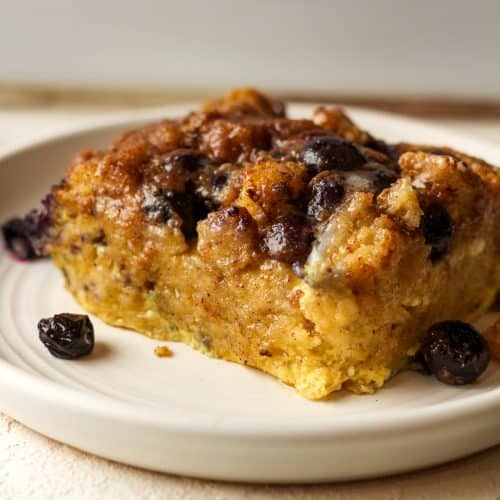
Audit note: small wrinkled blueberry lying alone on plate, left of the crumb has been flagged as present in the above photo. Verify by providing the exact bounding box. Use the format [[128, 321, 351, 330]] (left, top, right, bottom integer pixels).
[[38, 313, 94, 359]]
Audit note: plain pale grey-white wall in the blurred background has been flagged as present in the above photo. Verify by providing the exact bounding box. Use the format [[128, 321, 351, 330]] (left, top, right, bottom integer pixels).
[[0, 0, 500, 99]]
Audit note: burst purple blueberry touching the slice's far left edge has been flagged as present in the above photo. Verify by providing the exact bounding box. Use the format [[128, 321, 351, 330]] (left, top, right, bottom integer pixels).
[[2, 196, 50, 260]]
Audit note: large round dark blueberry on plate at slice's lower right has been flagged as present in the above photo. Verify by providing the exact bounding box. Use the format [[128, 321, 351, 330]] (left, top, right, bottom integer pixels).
[[422, 321, 490, 385]]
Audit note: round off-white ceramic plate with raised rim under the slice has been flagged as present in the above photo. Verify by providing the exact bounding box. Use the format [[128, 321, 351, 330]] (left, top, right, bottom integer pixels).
[[0, 106, 500, 482]]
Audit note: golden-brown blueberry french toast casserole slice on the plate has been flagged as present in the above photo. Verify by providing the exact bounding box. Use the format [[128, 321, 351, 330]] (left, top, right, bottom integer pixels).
[[32, 89, 500, 399]]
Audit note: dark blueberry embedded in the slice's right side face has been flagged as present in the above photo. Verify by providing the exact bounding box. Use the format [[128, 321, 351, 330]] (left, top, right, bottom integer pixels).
[[421, 203, 453, 262]]
